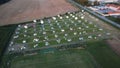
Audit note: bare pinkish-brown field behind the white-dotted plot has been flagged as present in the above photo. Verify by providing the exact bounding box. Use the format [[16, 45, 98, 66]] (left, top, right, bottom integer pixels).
[[0, 0, 78, 25]]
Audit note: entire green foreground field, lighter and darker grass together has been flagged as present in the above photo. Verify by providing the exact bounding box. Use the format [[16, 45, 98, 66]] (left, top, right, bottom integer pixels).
[[3, 40, 120, 68]]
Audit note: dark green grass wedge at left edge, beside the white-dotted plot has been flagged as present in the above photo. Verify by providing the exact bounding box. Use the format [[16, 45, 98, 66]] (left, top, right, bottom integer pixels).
[[0, 25, 16, 56]]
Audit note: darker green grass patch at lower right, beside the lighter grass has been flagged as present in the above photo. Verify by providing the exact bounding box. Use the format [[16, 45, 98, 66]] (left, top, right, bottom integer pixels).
[[87, 41, 120, 68]]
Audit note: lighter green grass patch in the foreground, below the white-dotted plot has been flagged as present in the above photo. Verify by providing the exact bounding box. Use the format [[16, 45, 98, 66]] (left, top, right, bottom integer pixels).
[[10, 49, 97, 68]]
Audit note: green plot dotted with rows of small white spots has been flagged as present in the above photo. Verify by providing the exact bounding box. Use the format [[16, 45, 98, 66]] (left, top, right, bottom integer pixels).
[[8, 10, 111, 51]]
